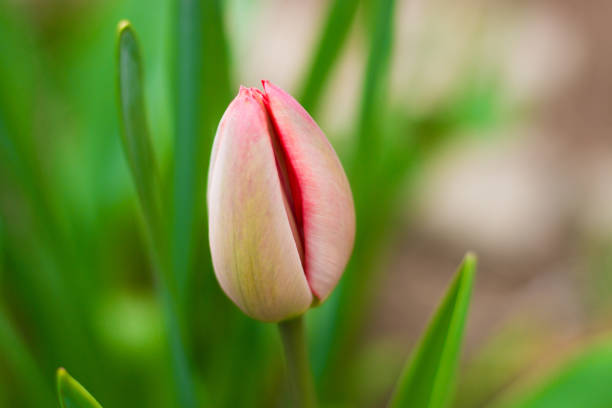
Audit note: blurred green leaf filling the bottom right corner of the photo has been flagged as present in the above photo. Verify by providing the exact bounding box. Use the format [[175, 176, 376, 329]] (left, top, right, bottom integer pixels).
[[493, 339, 612, 408]]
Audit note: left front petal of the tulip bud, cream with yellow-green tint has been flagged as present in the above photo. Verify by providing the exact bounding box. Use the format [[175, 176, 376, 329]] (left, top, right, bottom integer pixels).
[[208, 88, 312, 322]]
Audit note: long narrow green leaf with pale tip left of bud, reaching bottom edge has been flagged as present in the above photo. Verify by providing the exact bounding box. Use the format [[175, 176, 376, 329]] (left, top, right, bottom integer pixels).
[[117, 21, 196, 408]]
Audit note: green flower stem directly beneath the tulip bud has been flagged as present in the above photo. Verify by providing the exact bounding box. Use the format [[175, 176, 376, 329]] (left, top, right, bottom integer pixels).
[[278, 316, 317, 408]]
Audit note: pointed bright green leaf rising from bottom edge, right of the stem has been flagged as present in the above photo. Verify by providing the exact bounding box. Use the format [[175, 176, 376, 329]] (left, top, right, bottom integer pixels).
[[390, 254, 476, 408]]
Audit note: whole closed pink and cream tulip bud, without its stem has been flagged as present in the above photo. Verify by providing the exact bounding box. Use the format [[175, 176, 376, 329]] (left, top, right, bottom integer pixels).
[[207, 81, 355, 322]]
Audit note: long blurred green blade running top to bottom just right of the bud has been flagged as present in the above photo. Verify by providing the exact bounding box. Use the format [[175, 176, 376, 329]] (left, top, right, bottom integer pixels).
[[313, 0, 396, 399]]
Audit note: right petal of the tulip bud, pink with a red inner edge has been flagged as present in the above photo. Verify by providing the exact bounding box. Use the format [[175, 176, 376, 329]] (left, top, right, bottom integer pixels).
[[262, 81, 355, 301]]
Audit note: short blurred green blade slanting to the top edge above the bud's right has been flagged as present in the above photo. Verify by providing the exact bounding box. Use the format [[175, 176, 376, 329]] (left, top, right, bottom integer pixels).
[[298, 0, 359, 113]]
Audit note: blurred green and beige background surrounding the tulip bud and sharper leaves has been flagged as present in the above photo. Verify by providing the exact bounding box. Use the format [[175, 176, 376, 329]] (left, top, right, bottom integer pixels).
[[0, 0, 612, 407]]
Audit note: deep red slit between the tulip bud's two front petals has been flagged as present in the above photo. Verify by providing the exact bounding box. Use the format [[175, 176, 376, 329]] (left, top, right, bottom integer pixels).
[[262, 81, 308, 286]]
